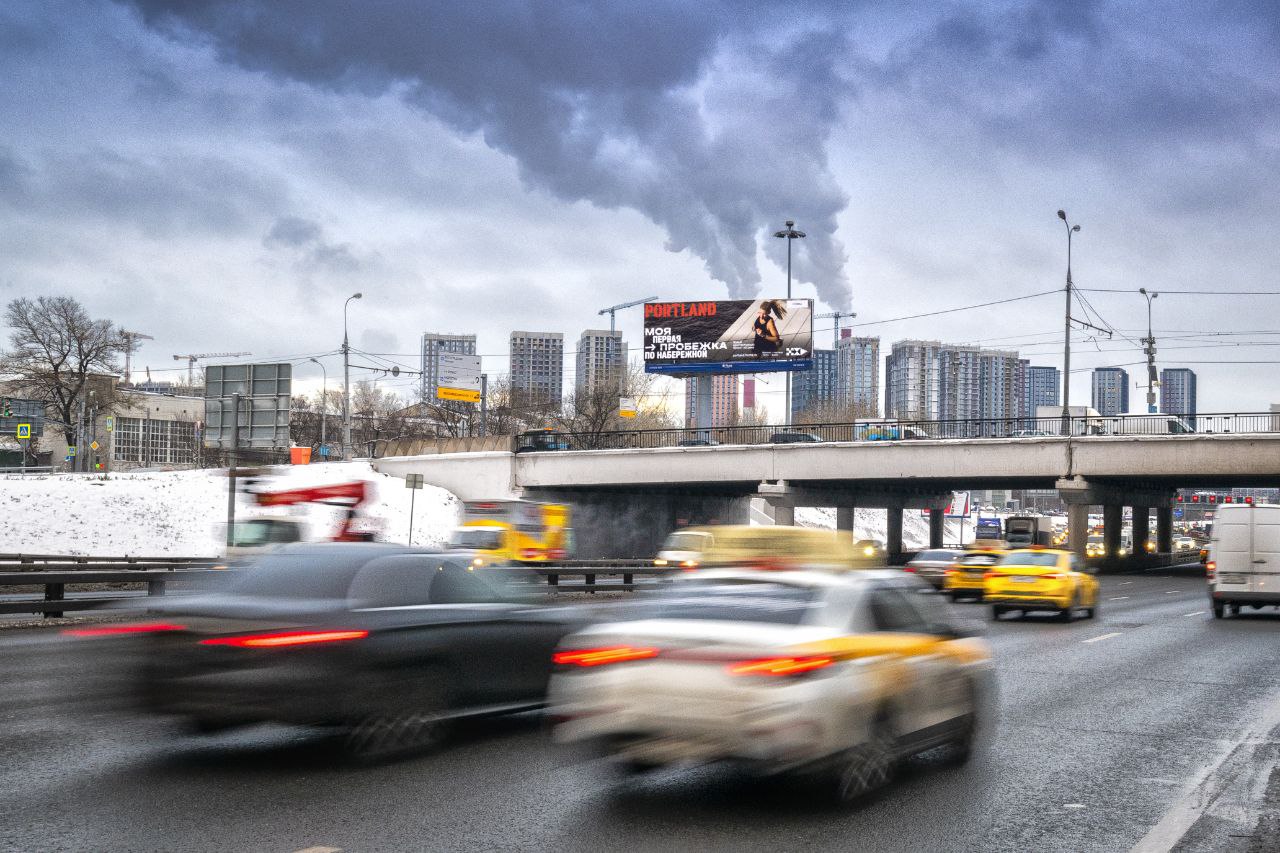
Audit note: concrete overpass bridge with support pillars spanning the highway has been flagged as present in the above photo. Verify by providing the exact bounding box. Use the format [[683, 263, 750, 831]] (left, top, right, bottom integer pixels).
[[375, 432, 1280, 557]]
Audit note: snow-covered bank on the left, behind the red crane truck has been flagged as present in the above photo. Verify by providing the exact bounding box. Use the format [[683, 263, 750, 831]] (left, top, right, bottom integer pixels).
[[0, 461, 461, 557]]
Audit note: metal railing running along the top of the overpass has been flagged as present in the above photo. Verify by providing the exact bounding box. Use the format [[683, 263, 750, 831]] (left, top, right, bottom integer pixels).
[[513, 412, 1280, 452]]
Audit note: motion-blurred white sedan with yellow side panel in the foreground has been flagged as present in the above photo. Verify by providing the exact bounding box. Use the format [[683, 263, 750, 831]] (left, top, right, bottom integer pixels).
[[550, 569, 993, 800]]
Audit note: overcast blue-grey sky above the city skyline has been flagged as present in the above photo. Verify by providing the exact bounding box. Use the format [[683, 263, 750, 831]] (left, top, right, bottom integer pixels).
[[0, 0, 1280, 411]]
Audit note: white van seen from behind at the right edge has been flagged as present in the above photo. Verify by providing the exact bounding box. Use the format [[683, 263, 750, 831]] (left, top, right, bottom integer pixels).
[[1206, 503, 1280, 619]]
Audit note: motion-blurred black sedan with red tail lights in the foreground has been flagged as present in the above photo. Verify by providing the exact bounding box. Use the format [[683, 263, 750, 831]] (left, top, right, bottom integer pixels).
[[116, 543, 580, 757]]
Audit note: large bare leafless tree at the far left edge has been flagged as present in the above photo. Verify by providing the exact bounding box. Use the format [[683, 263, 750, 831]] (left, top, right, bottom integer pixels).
[[0, 296, 128, 444]]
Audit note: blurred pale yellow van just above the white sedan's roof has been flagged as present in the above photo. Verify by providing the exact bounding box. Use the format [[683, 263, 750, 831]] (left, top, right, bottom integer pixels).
[[655, 524, 884, 569]]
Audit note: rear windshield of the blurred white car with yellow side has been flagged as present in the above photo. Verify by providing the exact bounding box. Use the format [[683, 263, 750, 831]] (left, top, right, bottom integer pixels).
[[653, 580, 820, 625]]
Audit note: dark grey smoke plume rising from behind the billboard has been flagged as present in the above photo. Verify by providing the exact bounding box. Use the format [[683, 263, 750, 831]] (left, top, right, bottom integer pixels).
[[124, 0, 849, 305]]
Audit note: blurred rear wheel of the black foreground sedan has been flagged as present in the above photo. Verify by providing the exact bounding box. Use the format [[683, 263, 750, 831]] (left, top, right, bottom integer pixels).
[[342, 672, 448, 762]]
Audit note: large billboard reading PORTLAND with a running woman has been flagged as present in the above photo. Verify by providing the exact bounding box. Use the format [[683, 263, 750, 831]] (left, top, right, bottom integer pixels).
[[644, 300, 813, 375]]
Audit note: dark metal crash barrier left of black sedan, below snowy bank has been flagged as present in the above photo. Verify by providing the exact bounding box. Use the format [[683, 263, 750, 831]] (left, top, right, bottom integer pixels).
[[0, 564, 227, 619]]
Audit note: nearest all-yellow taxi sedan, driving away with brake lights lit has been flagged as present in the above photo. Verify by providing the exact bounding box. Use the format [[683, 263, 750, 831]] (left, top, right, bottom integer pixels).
[[983, 548, 1098, 622]]
